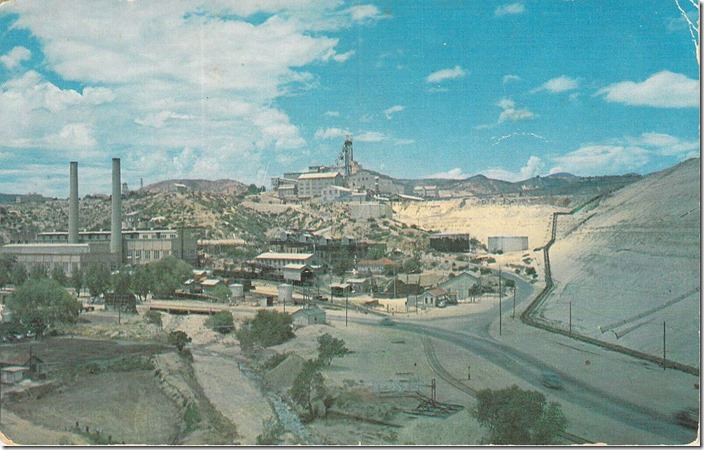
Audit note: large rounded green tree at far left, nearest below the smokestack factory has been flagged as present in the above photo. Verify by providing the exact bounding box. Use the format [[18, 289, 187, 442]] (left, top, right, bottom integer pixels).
[[7, 278, 81, 336]]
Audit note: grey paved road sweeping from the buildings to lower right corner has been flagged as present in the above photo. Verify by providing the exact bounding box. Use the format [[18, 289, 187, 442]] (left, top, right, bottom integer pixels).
[[336, 275, 696, 444]]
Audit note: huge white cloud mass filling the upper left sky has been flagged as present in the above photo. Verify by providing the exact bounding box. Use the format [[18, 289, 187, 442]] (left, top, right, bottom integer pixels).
[[0, 0, 380, 192]]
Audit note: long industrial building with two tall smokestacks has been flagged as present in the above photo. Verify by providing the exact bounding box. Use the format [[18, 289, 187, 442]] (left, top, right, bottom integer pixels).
[[0, 158, 198, 276]]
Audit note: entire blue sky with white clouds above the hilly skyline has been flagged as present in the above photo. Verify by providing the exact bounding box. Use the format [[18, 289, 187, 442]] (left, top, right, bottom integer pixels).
[[0, 0, 699, 197]]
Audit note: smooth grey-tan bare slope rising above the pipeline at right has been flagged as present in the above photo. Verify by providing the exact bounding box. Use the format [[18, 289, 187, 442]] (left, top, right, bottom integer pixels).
[[541, 158, 701, 367]]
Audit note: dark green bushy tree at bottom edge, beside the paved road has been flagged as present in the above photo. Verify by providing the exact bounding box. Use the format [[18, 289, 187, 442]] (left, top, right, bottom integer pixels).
[[474, 385, 567, 445]]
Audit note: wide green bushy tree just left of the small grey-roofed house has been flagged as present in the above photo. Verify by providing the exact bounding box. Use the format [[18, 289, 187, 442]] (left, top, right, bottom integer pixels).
[[235, 309, 296, 350]]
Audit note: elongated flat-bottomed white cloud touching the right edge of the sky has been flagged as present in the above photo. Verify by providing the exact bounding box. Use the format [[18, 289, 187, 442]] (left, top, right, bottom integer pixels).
[[597, 70, 699, 108]]
